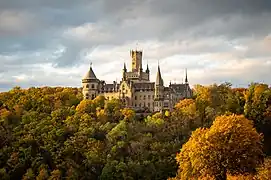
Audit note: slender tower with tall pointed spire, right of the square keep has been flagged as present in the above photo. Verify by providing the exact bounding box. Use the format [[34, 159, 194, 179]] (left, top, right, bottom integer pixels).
[[154, 65, 164, 112]]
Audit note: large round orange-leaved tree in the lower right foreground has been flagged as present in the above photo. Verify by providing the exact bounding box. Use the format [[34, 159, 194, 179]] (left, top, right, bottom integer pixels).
[[173, 115, 263, 180]]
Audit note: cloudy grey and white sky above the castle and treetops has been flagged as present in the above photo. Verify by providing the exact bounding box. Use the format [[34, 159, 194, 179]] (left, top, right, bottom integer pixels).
[[0, 0, 271, 91]]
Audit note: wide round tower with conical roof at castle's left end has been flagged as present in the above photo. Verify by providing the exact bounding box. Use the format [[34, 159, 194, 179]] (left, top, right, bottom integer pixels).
[[82, 64, 99, 99]]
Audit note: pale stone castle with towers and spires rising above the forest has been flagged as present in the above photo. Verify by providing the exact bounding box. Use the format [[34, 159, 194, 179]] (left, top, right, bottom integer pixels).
[[82, 50, 192, 112]]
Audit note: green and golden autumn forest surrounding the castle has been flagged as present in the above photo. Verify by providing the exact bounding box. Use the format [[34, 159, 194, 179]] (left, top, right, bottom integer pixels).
[[0, 83, 271, 180]]
